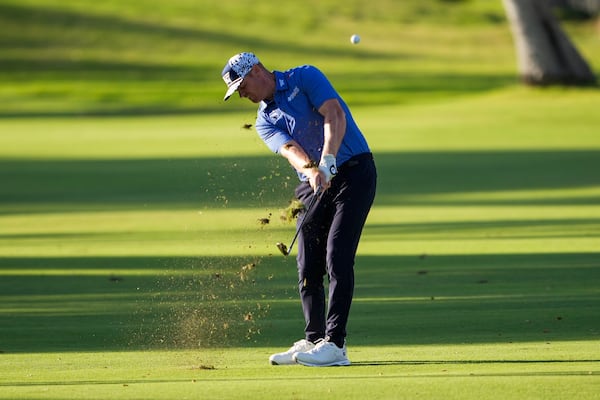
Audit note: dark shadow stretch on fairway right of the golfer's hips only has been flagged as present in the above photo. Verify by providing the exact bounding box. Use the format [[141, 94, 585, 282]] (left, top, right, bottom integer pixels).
[[376, 150, 600, 205]]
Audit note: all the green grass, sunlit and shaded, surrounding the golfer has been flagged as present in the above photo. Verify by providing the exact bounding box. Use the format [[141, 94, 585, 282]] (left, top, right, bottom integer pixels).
[[0, 0, 600, 400]]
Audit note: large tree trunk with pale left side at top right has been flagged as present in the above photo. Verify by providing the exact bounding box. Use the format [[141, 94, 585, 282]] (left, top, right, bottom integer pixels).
[[503, 0, 596, 85]]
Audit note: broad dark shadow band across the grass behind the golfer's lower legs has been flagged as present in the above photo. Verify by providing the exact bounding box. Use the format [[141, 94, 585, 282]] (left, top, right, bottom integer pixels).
[[0, 253, 600, 354]]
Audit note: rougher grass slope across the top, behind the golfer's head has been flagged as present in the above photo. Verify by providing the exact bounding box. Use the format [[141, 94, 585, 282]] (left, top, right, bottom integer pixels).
[[0, 0, 600, 116]]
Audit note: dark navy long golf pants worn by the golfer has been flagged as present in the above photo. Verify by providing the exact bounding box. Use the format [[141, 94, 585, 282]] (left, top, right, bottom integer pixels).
[[296, 153, 377, 347]]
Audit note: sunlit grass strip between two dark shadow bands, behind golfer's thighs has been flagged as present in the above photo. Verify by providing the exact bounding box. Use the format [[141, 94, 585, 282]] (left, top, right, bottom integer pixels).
[[0, 202, 600, 258]]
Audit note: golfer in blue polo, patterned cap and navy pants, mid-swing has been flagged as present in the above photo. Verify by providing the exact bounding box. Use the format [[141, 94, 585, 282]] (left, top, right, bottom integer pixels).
[[222, 53, 377, 367]]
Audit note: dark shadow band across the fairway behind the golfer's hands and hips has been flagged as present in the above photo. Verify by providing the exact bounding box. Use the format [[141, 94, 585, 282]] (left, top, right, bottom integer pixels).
[[0, 150, 600, 213]]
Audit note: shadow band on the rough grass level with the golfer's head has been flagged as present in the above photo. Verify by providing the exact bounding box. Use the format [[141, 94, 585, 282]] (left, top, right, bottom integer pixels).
[[0, 71, 515, 119]]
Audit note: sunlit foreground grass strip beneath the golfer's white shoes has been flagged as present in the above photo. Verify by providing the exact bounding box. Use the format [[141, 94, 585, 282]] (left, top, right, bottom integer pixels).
[[0, 342, 597, 399]]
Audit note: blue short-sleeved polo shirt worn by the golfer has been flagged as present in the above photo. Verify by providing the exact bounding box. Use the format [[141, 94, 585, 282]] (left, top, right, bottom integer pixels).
[[256, 65, 370, 180]]
